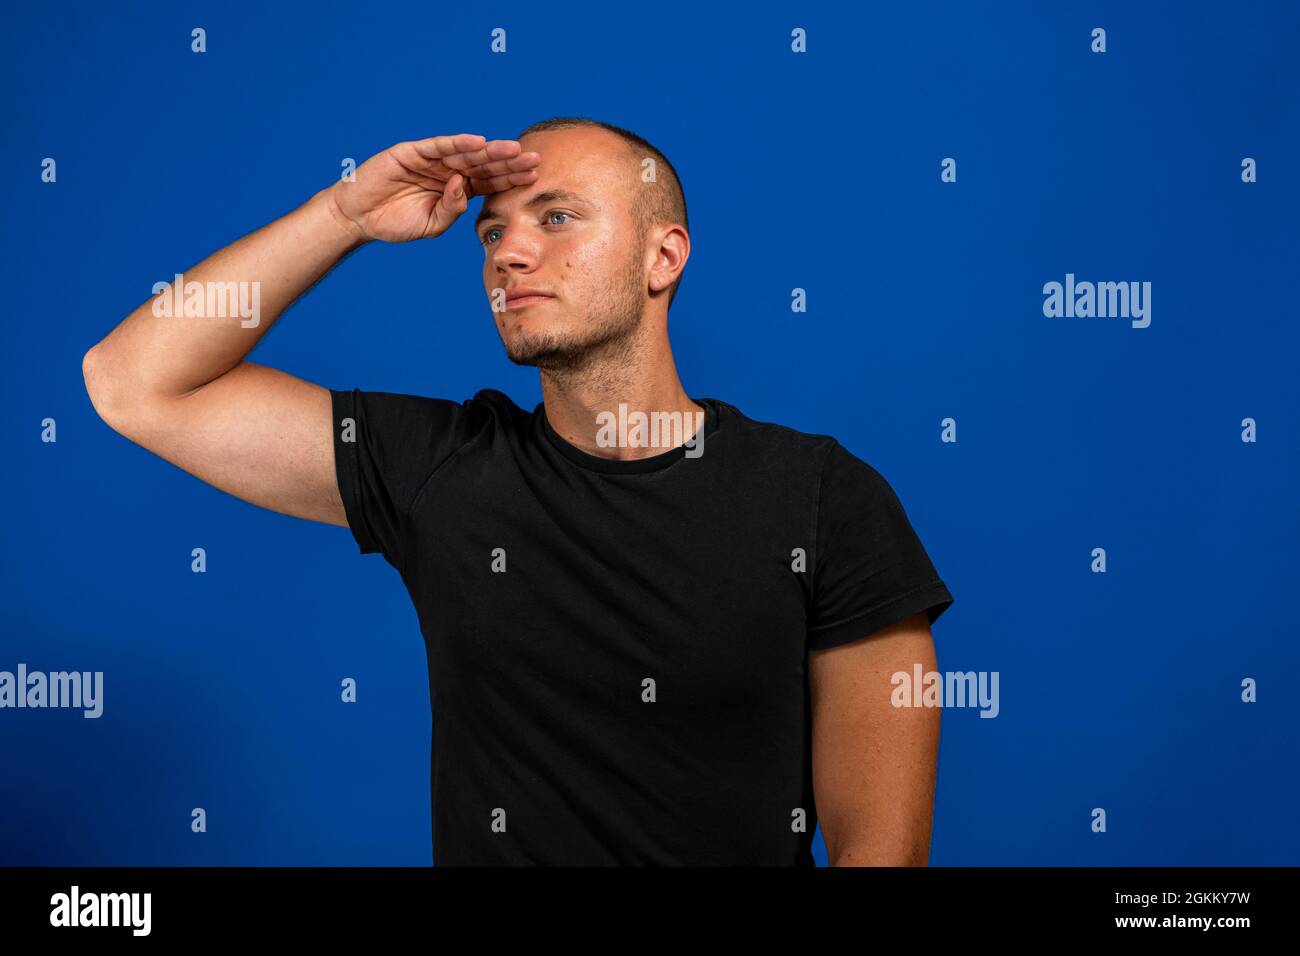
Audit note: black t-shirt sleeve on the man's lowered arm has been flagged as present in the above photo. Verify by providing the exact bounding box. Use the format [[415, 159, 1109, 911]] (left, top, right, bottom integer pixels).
[[807, 442, 953, 650]]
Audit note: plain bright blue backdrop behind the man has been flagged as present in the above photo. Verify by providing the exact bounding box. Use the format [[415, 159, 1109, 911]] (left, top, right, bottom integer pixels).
[[0, 3, 1300, 865]]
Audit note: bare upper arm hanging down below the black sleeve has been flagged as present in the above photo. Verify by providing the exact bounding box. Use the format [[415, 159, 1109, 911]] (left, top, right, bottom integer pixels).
[[809, 613, 940, 864]]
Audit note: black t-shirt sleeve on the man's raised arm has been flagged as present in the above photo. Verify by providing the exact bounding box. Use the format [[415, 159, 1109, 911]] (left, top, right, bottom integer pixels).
[[330, 389, 481, 571]]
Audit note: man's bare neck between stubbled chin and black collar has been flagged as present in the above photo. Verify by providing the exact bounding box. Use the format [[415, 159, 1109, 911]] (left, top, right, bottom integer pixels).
[[541, 317, 705, 459]]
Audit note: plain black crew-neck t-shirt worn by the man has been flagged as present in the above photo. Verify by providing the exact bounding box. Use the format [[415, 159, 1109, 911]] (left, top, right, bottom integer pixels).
[[332, 389, 953, 866]]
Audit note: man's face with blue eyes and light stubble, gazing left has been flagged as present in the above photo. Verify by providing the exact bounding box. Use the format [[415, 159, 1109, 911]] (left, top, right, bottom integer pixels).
[[476, 127, 647, 371]]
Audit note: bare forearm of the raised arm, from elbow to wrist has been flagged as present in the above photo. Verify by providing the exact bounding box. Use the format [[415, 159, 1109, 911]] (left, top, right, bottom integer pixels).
[[88, 189, 363, 402]]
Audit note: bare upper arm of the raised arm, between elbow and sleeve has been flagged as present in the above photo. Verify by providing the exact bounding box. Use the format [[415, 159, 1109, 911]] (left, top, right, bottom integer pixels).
[[101, 362, 347, 525]]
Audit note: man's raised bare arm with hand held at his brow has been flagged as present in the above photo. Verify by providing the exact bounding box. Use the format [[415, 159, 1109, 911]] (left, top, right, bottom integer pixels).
[[82, 133, 538, 525]]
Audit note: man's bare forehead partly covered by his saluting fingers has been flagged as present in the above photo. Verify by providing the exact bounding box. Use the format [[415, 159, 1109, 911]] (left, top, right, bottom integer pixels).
[[476, 127, 636, 222]]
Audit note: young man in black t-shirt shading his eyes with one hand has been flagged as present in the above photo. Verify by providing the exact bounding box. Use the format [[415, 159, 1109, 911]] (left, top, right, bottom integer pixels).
[[85, 118, 953, 865]]
